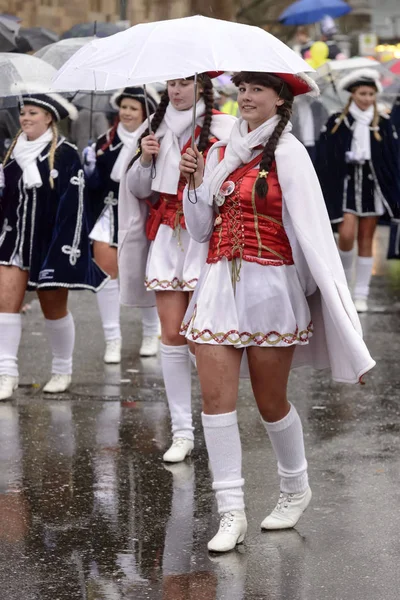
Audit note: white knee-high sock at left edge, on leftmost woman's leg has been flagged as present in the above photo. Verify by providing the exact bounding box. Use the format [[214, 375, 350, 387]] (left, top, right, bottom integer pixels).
[[0, 313, 22, 377]]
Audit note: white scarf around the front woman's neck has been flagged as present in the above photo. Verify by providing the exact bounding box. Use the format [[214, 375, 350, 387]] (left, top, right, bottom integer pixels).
[[208, 115, 292, 206]]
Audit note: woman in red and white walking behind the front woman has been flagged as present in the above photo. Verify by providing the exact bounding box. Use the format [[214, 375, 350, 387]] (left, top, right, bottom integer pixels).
[[120, 74, 236, 462]]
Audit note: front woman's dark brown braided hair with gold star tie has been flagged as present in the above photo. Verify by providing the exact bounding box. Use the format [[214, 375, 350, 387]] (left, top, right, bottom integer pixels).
[[232, 72, 293, 198]]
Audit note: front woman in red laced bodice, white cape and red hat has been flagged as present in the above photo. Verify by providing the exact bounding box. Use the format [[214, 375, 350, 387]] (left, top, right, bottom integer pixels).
[[181, 72, 375, 552]]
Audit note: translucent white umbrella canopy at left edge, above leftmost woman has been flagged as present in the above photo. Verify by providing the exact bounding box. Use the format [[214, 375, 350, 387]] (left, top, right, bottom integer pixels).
[[0, 52, 57, 106]]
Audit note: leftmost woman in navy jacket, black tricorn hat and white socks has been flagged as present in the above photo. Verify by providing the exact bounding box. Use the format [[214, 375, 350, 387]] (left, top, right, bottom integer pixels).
[[0, 93, 107, 400]]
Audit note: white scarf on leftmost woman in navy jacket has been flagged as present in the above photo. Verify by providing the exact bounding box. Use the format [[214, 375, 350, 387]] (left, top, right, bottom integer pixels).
[[13, 128, 53, 189]]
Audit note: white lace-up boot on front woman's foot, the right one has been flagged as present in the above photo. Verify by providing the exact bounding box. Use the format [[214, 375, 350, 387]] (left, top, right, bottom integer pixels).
[[261, 487, 312, 529]]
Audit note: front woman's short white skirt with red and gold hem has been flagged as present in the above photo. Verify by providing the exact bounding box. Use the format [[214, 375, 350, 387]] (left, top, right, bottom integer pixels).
[[181, 258, 313, 348]]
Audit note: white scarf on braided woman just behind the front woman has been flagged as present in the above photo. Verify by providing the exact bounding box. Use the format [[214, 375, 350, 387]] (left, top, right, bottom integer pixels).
[[151, 98, 206, 194]]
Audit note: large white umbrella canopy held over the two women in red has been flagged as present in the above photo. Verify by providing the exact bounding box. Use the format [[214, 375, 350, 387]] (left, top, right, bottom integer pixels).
[[53, 16, 312, 91]]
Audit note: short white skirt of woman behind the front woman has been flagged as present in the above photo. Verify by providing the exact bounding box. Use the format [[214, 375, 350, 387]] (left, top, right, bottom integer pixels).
[[145, 225, 208, 292]]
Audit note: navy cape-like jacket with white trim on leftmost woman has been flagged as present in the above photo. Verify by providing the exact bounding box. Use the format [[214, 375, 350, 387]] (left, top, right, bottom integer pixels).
[[0, 138, 106, 291]]
